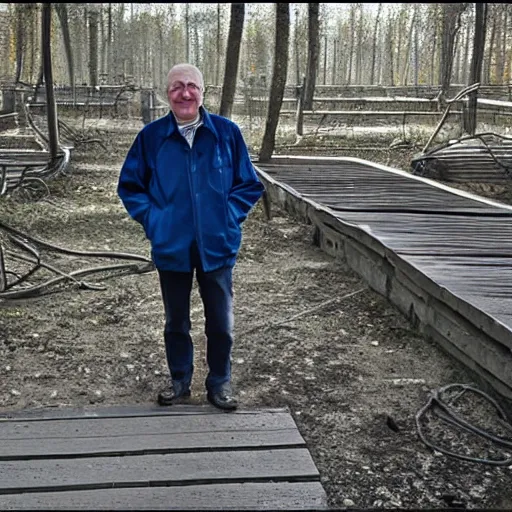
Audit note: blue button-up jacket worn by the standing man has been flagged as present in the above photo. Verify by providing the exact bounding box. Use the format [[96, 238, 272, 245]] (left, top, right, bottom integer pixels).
[[117, 107, 264, 272]]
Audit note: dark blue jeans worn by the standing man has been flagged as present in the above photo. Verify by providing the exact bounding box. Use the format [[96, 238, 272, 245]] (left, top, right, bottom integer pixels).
[[158, 244, 233, 392]]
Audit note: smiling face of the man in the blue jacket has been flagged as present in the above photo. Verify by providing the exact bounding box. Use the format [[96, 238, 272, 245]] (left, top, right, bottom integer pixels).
[[167, 68, 203, 123]]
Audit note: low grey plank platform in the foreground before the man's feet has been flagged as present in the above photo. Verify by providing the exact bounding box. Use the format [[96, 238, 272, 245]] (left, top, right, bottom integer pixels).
[[0, 405, 327, 510]]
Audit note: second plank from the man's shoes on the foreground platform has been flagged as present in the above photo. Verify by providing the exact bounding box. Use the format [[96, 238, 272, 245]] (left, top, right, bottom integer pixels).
[[0, 428, 305, 461]]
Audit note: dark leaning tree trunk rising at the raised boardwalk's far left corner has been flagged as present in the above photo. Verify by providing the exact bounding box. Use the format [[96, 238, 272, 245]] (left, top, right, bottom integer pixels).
[[259, 3, 290, 162]]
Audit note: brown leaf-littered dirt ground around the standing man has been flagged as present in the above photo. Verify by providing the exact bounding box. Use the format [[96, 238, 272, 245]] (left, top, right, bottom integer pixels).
[[0, 119, 512, 509]]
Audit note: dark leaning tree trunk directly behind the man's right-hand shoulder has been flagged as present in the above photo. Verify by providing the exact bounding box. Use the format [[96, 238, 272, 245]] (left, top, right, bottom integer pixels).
[[219, 4, 245, 117]]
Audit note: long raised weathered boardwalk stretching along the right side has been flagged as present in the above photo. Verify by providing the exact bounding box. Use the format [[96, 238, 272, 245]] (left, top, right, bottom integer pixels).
[[256, 156, 512, 403]]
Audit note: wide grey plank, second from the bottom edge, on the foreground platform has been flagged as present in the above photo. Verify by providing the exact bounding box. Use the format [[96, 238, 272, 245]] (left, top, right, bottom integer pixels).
[[0, 448, 319, 494]]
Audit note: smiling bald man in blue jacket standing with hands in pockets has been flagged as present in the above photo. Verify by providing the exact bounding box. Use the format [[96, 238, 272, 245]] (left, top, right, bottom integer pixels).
[[118, 64, 264, 410]]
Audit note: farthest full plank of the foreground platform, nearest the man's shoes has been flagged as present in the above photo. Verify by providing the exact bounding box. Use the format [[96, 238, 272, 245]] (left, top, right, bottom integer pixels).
[[0, 413, 295, 441]]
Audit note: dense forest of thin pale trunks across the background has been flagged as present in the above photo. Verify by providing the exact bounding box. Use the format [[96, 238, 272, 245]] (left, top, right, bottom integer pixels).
[[0, 3, 512, 93]]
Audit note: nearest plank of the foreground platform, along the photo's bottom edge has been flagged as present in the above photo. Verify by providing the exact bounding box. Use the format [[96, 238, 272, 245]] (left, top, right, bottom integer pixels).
[[0, 482, 327, 510]]
